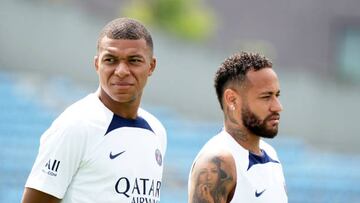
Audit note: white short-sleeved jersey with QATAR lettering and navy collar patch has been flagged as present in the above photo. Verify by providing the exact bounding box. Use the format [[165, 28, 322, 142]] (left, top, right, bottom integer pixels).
[[25, 93, 166, 203]]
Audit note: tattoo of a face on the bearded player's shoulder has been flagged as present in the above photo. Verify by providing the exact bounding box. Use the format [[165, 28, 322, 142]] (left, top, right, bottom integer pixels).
[[192, 157, 233, 203]]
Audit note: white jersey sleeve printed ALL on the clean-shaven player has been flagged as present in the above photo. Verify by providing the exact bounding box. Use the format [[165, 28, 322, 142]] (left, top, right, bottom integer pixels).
[[25, 118, 86, 199]]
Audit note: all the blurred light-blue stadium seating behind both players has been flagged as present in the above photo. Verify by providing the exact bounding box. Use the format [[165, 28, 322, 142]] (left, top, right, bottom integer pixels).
[[0, 71, 360, 203]]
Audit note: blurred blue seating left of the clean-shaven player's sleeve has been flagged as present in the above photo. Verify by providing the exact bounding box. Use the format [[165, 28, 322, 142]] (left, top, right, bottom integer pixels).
[[0, 72, 53, 203]]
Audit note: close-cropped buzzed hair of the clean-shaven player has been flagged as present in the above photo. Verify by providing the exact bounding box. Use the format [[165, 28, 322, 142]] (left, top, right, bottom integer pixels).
[[97, 18, 154, 53]]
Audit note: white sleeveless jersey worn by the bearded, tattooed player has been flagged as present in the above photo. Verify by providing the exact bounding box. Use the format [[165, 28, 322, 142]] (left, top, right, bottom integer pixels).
[[189, 130, 288, 203]]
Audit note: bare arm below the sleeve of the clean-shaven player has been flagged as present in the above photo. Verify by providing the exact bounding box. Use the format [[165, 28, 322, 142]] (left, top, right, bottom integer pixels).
[[21, 188, 61, 203]]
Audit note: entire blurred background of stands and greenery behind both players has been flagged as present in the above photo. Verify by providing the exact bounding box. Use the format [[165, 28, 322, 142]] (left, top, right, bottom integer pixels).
[[0, 0, 360, 203]]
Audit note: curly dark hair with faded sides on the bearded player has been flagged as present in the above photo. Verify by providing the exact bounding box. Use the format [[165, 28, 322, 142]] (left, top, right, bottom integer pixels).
[[214, 52, 272, 109]]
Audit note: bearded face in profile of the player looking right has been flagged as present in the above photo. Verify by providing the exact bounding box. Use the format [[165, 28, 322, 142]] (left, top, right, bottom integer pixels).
[[241, 68, 282, 138]]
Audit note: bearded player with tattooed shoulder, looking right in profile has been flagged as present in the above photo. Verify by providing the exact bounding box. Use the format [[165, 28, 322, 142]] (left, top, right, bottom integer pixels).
[[188, 52, 287, 203]]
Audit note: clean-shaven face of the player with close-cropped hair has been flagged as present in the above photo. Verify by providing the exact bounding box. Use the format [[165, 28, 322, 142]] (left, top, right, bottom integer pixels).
[[95, 37, 155, 107]]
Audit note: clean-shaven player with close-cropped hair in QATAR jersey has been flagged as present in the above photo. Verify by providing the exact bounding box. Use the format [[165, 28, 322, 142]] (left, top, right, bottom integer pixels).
[[22, 18, 166, 203]]
